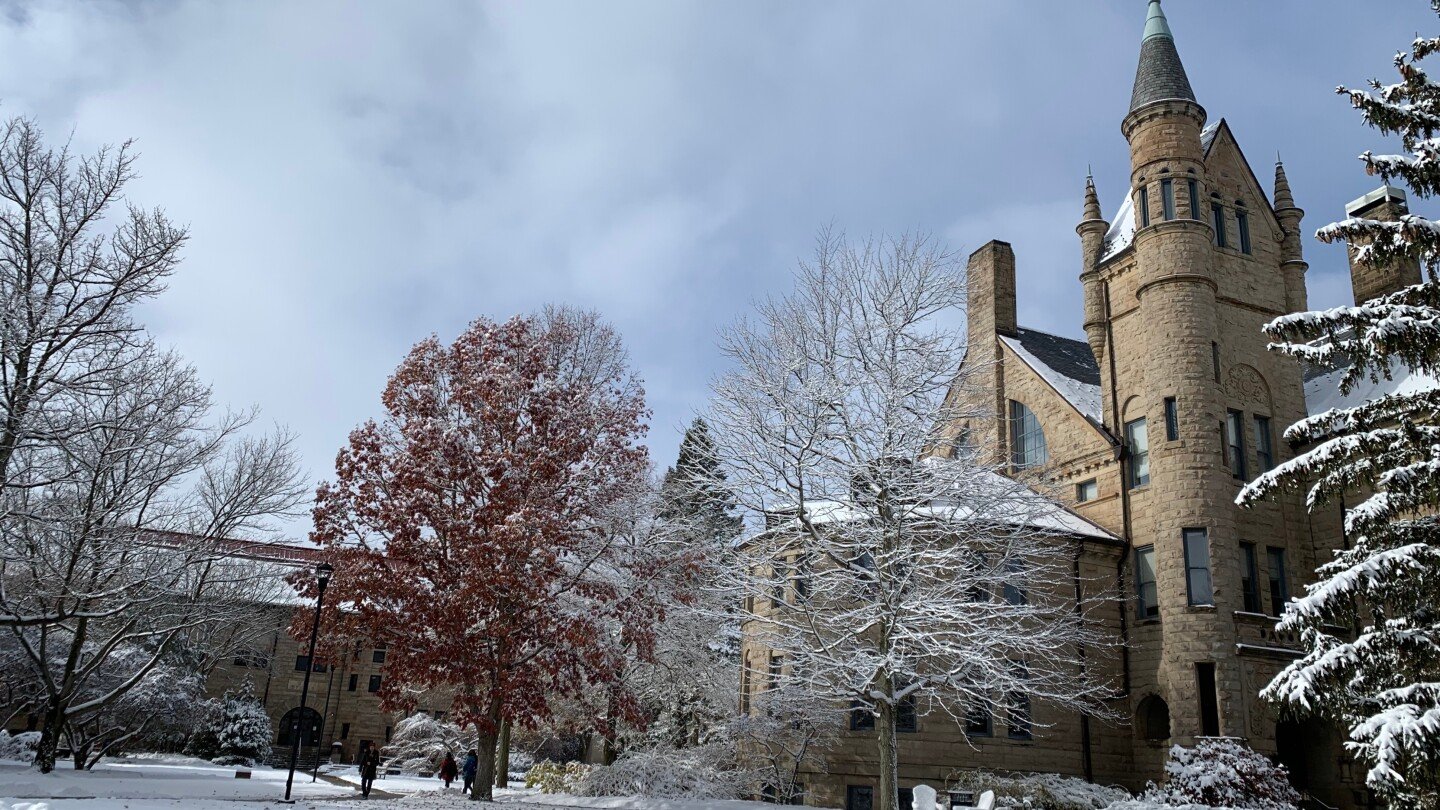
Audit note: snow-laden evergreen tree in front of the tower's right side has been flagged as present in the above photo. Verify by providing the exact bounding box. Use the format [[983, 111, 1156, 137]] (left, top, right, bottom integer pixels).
[[1240, 0, 1440, 809]]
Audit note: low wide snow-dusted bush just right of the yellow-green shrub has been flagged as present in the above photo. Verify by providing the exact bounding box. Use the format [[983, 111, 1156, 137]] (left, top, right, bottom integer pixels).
[[567, 745, 749, 798]]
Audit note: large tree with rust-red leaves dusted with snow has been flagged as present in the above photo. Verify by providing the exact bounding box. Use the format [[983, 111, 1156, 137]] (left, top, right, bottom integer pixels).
[[309, 308, 671, 798]]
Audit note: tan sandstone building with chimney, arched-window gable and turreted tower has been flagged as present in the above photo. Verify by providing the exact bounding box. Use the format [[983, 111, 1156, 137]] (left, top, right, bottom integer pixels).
[[744, 0, 1393, 810]]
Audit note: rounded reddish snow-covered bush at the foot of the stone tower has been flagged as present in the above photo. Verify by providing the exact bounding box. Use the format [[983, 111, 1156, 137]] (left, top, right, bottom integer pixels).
[[1145, 738, 1300, 810]]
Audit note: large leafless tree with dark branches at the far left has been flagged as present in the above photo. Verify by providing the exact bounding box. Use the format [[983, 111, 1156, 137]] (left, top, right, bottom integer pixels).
[[0, 120, 302, 771]]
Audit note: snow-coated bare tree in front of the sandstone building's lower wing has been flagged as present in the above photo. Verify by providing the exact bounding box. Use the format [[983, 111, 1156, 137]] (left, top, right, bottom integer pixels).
[[707, 233, 1107, 810]]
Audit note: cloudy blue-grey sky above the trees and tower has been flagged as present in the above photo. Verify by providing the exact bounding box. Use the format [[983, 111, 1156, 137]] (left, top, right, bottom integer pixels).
[[0, 0, 1422, 538]]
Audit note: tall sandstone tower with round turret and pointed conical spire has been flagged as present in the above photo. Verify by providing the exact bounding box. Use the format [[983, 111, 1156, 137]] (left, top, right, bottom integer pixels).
[[1077, 0, 1315, 770]]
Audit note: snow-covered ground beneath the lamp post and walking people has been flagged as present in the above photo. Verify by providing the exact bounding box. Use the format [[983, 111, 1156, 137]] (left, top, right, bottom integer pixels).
[[0, 755, 773, 810]]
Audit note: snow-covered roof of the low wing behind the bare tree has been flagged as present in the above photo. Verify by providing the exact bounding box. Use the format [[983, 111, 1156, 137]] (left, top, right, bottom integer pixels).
[[771, 458, 1119, 542]]
